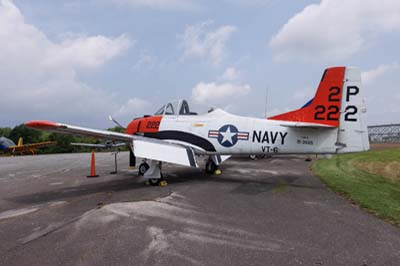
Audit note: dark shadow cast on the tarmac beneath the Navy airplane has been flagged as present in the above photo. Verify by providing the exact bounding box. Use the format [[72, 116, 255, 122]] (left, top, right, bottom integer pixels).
[[5, 161, 321, 204]]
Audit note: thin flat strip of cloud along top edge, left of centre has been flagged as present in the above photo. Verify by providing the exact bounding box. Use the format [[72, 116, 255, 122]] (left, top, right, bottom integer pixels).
[[108, 0, 199, 11]]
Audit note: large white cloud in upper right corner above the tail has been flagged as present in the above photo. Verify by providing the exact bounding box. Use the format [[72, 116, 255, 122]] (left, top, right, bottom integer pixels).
[[270, 0, 400, 61]]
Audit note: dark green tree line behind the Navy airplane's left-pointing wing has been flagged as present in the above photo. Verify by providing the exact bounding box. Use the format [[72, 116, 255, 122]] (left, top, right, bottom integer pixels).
[[0, 124, 125, 154]]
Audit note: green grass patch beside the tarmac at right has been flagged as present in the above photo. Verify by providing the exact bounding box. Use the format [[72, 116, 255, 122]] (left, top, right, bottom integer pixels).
[[312, 149, 400, 226]]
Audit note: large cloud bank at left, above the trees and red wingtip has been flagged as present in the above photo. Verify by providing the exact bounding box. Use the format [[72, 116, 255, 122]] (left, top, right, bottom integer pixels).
[[0, 0, 135, 125]]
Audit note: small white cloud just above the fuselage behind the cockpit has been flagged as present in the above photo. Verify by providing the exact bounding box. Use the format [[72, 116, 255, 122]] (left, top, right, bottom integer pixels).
[[192, 82, 251, 104]]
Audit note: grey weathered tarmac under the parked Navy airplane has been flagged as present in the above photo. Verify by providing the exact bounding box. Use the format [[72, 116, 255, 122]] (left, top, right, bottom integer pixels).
[[0, 153, 400, 266]]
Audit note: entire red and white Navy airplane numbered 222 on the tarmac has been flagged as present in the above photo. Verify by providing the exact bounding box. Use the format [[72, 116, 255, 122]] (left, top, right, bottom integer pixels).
[[25, 66, 369, 185]]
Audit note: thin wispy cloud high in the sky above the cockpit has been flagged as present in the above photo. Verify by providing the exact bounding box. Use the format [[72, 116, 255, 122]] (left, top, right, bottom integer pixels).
[[179, 21, 236, 66]]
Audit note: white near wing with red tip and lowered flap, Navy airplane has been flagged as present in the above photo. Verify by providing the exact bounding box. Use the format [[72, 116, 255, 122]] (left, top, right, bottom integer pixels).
[[25, 121, 198, 167]]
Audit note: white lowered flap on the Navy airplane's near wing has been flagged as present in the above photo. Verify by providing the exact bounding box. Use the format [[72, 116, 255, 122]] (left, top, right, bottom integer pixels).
[[133, 140, 198, 167]]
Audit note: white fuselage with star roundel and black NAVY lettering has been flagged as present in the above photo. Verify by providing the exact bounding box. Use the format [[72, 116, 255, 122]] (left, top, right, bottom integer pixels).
[[159, 109, 338, 155]]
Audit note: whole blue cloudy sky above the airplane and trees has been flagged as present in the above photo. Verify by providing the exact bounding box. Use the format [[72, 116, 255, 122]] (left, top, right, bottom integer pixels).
[[0, 0, 400, 128]]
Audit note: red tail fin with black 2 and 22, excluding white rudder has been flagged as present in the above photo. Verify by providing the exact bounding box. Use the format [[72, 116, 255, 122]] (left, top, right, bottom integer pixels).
[[268, 67, 345, 127]]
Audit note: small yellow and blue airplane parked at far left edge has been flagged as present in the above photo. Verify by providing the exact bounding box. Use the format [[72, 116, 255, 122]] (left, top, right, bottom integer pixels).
[[0, 137, 57, 155]]
